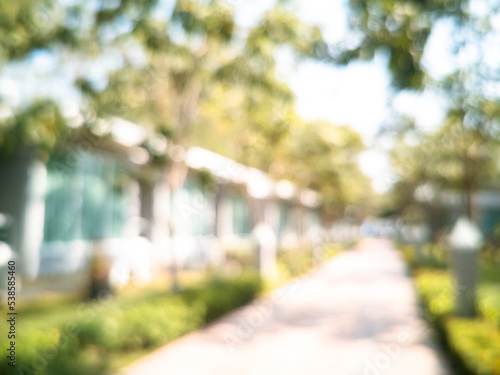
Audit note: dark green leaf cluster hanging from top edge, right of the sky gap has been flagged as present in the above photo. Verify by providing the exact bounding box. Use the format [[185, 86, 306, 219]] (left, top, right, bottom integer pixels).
[[342, 0, 469, 89]]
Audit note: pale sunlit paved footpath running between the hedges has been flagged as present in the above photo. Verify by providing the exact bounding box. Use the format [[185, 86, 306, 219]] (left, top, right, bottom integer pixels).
[[120, 239, 449, 375]]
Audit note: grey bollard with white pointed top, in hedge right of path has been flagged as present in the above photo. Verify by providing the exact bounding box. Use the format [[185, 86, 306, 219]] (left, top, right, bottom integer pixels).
[[449, 217, 483, 317]]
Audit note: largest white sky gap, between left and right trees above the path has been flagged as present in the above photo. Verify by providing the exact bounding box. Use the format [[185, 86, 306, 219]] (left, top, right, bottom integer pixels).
[[290, 61, 391, 192]]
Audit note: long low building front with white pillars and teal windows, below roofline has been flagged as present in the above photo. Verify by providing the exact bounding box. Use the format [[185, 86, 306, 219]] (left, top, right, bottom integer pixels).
[[0, 144, 324, 288]]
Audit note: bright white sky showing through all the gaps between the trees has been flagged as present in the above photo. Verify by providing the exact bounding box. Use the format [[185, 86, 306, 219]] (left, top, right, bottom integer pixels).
[[235, 0, 452, 192]]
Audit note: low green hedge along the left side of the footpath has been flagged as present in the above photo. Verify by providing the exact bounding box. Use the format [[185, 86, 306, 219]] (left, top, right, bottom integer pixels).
[[0, 274, 262, 375]]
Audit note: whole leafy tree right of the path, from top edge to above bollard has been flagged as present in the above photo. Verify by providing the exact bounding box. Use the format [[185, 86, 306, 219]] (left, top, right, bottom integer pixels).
[[342, 0, 500, 225]]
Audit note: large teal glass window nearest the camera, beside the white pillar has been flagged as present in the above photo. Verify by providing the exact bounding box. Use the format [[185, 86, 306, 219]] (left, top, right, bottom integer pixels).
[[44, 154, 133, 242]]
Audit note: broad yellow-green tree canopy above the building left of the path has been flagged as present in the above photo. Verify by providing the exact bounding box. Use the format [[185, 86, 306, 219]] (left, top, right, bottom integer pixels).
[[0, 0, 374, 220]]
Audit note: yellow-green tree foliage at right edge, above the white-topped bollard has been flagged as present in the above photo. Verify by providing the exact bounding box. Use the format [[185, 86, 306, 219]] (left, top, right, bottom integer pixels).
[[392, 103, 500, 223]]
